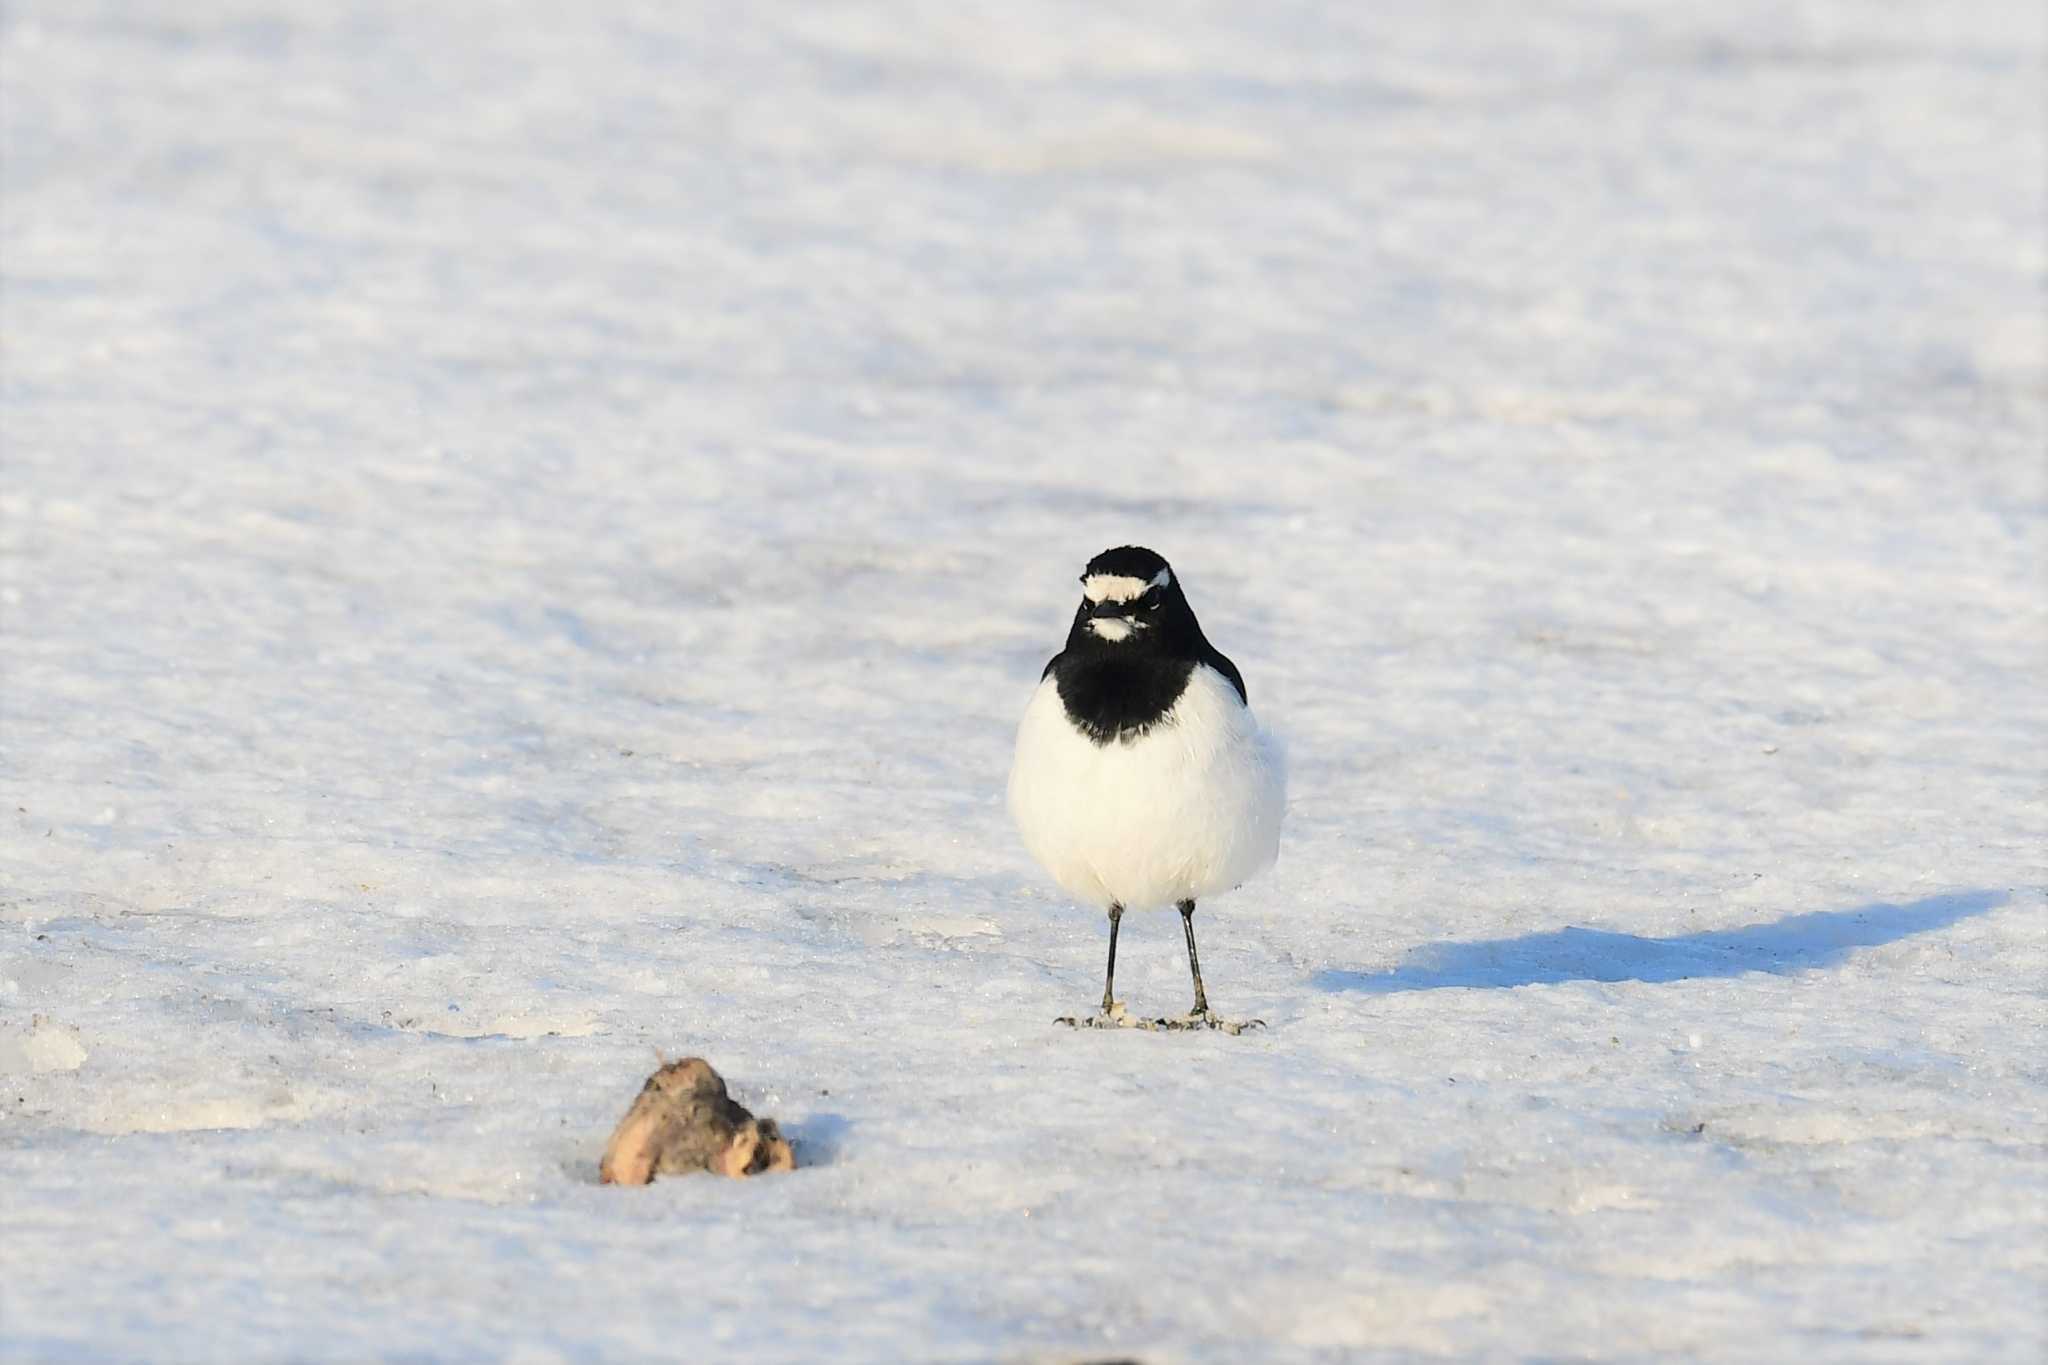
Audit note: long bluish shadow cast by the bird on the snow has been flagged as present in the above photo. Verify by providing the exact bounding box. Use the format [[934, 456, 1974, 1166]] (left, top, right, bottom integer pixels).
[[1311, 890, 2009, 995]]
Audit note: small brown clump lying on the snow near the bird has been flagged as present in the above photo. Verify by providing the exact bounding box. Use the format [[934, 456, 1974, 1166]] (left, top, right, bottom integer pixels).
[[598, 1056, 797, 1185]]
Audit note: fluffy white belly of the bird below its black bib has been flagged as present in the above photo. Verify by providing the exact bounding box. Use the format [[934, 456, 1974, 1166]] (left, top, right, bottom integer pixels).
[[1010, 663, 1286, 911]]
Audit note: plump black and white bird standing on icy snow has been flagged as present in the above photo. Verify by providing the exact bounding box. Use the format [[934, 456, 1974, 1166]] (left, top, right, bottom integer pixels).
[[1010, 544, 1286, 1031]]
